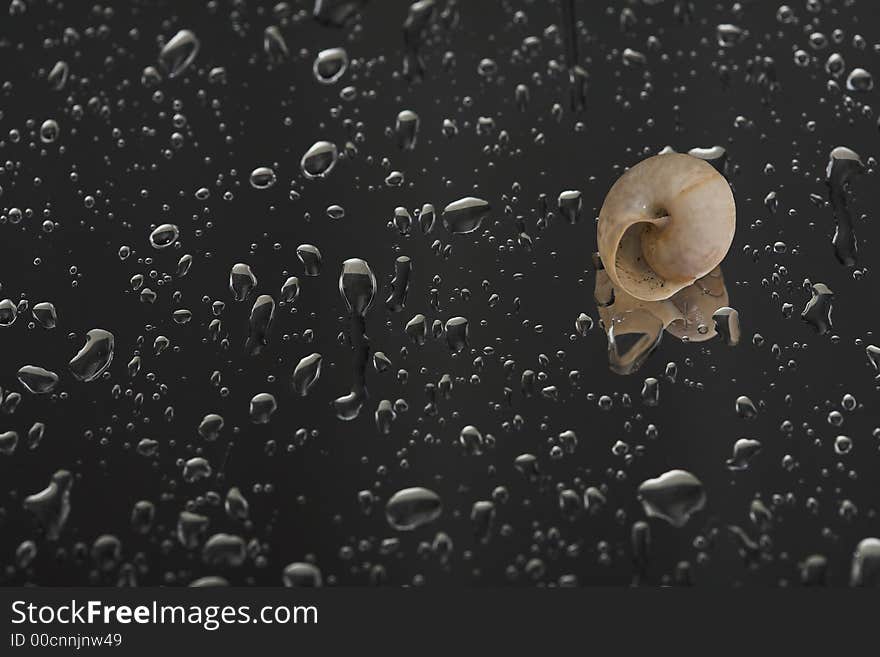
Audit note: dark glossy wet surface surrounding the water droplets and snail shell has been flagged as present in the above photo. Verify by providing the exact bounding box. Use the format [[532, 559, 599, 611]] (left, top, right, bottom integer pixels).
[[0, 0, 880, 586]]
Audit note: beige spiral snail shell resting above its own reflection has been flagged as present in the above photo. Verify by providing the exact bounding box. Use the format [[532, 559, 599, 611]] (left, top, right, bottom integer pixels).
[[597, 153, 736, 301]]
